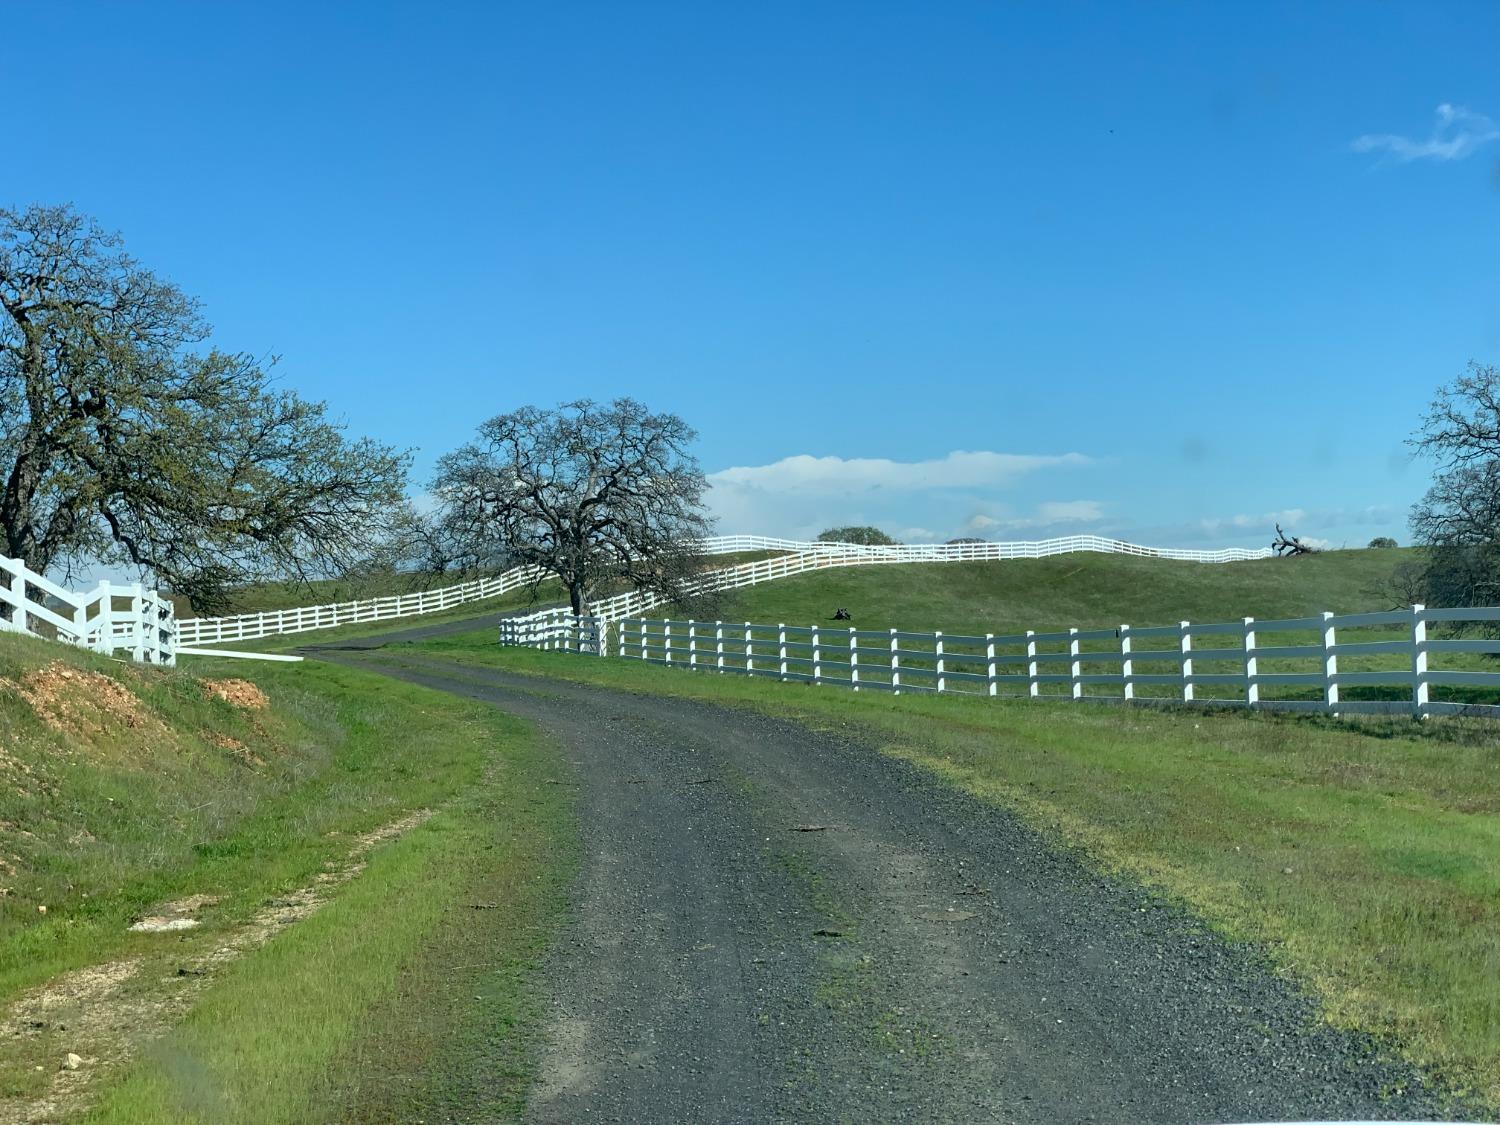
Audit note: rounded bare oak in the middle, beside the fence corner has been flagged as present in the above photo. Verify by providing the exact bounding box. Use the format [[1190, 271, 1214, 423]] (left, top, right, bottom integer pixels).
[[434, 399, 711, 614]]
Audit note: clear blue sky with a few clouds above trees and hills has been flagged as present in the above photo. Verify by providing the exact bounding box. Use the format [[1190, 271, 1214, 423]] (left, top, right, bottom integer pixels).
[[0, 0, 1500, 546]]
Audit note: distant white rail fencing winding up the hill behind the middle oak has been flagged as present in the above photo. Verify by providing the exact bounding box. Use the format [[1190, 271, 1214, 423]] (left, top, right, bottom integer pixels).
[[177, 536, 1271, 645]]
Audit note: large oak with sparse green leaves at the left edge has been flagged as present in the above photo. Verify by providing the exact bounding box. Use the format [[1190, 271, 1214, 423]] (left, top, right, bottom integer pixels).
[[0, 207, 407, 611]]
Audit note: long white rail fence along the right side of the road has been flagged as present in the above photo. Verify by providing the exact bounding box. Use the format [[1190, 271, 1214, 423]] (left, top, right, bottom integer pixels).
[[500, 606, 1500, 719]]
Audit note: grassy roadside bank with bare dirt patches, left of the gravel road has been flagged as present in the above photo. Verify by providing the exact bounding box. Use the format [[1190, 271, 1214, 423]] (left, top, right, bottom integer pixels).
[[0, 636, 573, 1122]]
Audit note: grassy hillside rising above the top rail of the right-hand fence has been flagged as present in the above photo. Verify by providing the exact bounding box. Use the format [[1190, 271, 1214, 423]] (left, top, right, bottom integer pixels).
[[719, 549, 1416, 633]]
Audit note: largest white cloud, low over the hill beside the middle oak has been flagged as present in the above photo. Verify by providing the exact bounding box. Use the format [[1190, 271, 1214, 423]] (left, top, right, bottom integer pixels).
[[708, 450, 1092, 543]]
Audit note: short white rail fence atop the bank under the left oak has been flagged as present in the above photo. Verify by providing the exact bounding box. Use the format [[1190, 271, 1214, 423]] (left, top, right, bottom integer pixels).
[[0, 558, 177, 665]]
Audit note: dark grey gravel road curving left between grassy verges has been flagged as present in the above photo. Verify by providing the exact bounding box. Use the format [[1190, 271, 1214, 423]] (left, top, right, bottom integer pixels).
[[314, 639, 1464, 1125]]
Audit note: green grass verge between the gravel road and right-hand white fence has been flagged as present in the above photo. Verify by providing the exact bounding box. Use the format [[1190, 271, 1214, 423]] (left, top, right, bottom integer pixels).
[[405, 636, 1500, 1104]]
